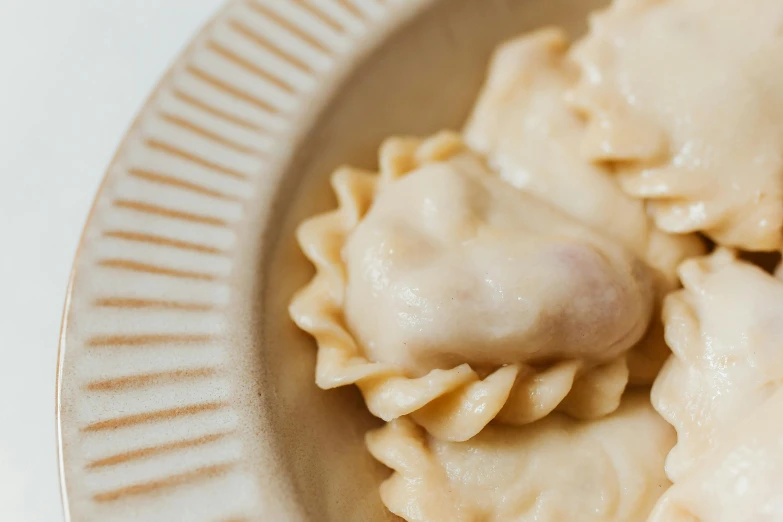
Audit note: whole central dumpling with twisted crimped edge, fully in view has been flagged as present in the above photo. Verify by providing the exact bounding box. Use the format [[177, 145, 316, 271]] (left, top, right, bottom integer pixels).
[[290, 133, 653, 440]]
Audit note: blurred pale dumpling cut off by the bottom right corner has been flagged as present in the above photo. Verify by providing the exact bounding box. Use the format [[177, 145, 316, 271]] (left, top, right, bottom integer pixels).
[[649, 390, 783, 522]]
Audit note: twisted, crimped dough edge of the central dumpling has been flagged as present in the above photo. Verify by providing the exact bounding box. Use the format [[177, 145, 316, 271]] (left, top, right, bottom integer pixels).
[[289, 131, 628, 441]]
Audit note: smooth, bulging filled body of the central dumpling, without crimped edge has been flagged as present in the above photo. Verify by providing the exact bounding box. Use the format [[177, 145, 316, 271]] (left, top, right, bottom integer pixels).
[[350, 134, 652, 377]]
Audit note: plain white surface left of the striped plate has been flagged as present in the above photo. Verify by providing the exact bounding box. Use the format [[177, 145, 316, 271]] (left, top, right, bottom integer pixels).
[[0, 0, 222, 522]]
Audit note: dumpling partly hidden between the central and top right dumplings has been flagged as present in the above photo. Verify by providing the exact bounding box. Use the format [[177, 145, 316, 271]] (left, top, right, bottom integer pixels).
[[464, 28, 703, 384]]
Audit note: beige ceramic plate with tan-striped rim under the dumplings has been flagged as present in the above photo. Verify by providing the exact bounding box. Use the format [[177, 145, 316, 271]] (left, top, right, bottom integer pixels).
[[57, 0, 600, 522]]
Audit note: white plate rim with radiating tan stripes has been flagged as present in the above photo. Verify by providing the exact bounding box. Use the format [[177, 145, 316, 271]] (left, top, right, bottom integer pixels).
[[56, 0, 431, 522]]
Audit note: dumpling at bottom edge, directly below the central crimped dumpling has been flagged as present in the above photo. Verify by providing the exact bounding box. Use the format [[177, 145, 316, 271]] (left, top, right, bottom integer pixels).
[[367, 391, 675, 522]]
